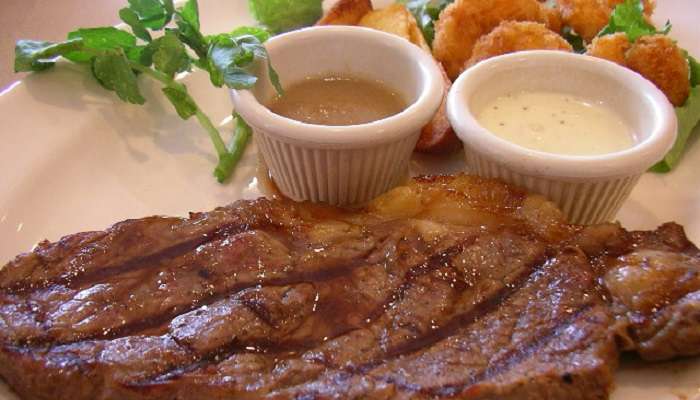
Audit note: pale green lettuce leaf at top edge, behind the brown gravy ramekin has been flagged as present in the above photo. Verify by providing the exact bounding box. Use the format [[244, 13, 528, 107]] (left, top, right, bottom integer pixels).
[[248, 0, 323, 33]]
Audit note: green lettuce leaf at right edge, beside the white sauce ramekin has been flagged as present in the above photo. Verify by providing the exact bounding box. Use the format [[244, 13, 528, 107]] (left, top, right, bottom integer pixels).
[[651, 56, 700, 172]]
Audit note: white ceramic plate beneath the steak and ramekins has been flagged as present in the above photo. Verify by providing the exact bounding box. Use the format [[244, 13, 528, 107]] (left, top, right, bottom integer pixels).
[[0, 0, 700, 400]]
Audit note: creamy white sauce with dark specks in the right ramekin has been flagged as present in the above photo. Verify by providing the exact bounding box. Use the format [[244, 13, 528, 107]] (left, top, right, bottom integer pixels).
[[477, 91, 635, 156]]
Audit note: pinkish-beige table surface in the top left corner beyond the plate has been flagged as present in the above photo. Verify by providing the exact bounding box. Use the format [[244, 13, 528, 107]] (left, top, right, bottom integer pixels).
[[0, 0, 121, 89]]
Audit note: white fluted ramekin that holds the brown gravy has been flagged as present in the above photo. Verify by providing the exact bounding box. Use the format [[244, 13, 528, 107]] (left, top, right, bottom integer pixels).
[[231, 26, 444, 205]]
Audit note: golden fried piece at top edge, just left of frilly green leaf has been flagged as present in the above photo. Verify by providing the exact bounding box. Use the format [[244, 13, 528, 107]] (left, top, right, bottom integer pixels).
[[557, 0, 655, 42]]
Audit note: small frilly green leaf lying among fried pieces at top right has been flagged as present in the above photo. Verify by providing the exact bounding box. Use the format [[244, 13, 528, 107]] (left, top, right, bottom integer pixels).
[[598, 0, 671, 42]]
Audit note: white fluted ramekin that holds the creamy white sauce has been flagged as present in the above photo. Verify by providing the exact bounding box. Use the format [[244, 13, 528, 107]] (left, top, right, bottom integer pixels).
[[447, 50, 677, 224]]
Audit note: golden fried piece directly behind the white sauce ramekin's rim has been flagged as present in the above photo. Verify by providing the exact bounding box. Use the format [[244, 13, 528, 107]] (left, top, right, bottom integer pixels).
[[465, 21, 573, 68]]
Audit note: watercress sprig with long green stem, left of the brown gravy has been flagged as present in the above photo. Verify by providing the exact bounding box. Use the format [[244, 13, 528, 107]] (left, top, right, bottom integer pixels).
[[15, 0, 282, 182]]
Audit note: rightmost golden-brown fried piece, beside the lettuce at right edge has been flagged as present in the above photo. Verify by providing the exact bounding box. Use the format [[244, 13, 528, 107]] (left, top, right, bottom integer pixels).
[[626, 35, 690, 107]]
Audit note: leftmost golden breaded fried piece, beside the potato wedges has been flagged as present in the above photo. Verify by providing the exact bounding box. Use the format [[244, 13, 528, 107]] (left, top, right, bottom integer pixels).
[[433, 0, 557, 80]]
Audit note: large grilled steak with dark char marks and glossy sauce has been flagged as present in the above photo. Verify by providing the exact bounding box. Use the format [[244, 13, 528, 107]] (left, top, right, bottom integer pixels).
[[0, 176, 700, 400]]
